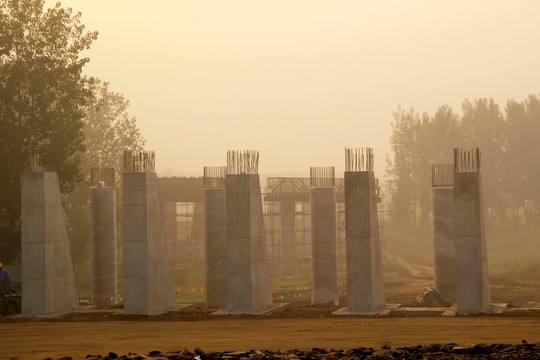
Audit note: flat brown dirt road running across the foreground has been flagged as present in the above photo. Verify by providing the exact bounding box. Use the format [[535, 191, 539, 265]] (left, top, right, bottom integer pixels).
[[0, 317, 540, 359]]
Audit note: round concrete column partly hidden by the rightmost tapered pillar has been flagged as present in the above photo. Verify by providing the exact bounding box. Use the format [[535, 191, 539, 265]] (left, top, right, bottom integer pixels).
[[431, 164, 457, 303]]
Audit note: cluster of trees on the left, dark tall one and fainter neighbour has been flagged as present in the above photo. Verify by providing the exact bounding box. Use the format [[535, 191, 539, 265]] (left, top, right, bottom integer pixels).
[[0, 0, 144, 263]]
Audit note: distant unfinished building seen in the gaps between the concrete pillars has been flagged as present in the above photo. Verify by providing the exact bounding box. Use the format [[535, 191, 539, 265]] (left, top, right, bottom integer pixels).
[[154, 177, 385, 276]]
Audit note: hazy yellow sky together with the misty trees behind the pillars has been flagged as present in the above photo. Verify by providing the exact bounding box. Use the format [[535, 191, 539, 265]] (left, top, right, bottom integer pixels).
[[0, 0, 540, 292]]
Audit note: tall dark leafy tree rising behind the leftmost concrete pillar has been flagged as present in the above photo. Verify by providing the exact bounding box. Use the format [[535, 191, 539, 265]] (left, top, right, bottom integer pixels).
[[0, 0, 97, 262]]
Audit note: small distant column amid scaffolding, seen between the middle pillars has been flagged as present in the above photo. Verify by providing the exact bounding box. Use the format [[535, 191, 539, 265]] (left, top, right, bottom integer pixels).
[[279, 201, 297, 277]]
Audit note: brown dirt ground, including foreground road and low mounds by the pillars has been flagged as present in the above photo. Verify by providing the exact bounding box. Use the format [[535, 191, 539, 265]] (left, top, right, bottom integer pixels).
[[4, 260, 540, 359]]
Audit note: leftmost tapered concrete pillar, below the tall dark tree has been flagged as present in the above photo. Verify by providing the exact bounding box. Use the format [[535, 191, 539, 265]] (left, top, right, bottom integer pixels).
[[21, 171, 78, 316]]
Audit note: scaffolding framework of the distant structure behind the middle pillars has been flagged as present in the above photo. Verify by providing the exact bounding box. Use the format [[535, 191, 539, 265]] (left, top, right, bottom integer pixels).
[[158, 177, 387, 276]]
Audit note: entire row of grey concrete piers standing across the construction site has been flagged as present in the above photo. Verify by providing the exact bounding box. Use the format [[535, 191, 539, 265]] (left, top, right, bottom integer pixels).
[[17, 149, 490, 316]]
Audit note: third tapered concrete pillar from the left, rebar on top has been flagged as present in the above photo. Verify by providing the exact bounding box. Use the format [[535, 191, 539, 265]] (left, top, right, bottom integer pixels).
[[226, 151, 272, 313]]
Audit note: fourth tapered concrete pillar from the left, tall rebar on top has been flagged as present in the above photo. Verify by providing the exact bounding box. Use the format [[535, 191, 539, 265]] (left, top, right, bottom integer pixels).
[[345, 148, 385, 313]]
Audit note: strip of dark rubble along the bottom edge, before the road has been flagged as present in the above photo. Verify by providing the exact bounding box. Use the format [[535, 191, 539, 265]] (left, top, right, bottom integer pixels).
[[75, 340, 540, 360]]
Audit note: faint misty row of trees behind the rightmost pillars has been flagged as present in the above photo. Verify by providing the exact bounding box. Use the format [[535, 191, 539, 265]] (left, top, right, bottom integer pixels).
[[387, 95, 540, 245]]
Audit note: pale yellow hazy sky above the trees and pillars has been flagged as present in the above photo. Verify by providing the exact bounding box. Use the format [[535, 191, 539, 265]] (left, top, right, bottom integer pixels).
[[47, 0, 540, 177]]
